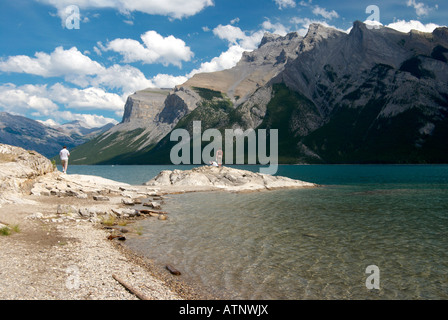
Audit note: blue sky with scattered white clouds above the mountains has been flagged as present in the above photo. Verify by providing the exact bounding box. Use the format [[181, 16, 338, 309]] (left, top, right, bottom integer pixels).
[[0, 0, 448, 127]]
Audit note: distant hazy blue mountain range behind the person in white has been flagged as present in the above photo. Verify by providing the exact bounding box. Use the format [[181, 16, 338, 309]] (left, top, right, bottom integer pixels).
[[0, 112, 111, 158]]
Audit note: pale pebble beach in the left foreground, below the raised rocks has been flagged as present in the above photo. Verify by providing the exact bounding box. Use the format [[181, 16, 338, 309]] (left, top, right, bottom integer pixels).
[[0, 173, 213, 300]]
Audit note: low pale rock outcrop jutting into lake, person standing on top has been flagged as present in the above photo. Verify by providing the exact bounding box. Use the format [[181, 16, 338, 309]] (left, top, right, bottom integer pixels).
[[146, 166, 317, 192]]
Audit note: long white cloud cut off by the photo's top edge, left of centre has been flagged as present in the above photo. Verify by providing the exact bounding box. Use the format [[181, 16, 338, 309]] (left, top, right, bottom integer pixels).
[[36, 0, 214, 20]]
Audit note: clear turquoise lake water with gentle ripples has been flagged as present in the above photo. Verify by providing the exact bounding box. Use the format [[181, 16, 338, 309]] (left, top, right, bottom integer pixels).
[[69, 165, 448, 300]]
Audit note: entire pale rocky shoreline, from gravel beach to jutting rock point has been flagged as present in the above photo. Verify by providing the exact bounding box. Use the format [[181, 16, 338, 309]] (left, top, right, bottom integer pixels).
[[0, 144, 315, 300]]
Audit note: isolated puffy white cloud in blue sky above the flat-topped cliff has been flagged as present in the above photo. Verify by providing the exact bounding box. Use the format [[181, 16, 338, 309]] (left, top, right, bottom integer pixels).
[[105, 30, 194, 67]]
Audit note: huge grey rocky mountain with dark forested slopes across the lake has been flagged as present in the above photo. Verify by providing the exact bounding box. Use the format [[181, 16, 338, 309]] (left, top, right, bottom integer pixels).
[[70, 21, 448, 164]]
